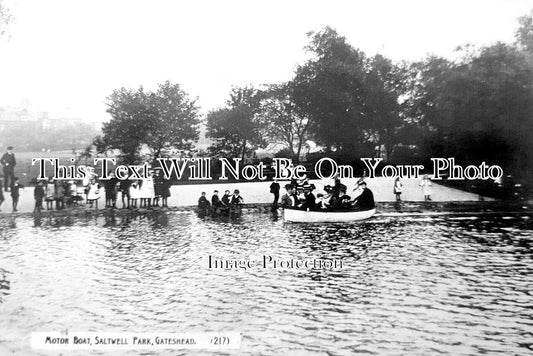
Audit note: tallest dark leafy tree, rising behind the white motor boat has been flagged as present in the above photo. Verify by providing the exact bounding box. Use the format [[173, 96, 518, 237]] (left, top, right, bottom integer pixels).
[[293, 27, 367, 151]]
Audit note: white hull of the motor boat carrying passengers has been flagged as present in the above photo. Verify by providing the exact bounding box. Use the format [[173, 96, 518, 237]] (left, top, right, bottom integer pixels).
[[283, 209, 376, 223]]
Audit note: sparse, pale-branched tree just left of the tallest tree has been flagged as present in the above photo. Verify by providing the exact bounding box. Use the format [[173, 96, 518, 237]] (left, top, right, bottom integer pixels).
[[260, 82, 312, 163]]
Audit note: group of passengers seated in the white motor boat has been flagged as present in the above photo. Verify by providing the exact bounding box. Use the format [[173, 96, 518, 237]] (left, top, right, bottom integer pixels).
[[273, 178, 375, 211]]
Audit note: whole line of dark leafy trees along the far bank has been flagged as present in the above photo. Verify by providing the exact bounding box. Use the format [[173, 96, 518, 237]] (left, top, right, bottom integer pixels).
[[95, 12, 533, 184]]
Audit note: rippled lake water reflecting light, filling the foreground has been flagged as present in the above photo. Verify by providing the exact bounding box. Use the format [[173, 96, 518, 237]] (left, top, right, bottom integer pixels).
[[0, 212, 533, 355]]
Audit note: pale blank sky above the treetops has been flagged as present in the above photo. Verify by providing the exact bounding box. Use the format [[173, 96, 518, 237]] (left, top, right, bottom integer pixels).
[[0, 0, 533, 122]]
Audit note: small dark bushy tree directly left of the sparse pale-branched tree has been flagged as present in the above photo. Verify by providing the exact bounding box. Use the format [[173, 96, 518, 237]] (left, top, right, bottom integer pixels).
[[207, 87, 265, 160]]
